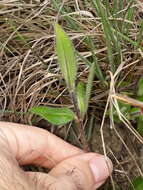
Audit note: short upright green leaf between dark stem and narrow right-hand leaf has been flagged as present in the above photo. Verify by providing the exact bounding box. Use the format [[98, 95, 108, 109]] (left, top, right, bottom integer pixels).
[[76, 82, 86, 118]]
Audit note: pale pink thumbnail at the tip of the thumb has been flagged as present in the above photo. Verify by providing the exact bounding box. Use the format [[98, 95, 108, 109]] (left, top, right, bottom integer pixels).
[[89, 156, 113, 183]]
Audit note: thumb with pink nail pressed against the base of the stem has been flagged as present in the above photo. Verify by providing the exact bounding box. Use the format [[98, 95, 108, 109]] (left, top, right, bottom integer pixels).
[[29, 153, 113, 190]]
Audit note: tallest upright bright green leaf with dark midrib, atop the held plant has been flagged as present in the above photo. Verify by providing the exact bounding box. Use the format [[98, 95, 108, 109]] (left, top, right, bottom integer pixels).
[[55, 24, 77, 91]]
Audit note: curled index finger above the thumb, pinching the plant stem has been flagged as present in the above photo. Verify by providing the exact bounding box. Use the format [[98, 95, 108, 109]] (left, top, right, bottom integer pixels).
[[0, 122, 83, 168]]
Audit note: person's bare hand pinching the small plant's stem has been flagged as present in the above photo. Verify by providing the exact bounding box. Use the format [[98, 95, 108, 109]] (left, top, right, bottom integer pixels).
[[0, 122, 113, 190]]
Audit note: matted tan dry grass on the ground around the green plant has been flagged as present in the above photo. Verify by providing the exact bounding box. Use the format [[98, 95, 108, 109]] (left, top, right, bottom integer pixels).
[[0, 0, 143, 189]]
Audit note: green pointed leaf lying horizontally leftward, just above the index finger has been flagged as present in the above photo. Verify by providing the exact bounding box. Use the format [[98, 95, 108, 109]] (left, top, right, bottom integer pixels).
[[29, 106, 75, 125]]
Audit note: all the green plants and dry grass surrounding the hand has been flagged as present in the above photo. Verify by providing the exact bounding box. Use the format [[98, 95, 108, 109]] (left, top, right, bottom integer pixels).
[[0, 0, 143, 190]]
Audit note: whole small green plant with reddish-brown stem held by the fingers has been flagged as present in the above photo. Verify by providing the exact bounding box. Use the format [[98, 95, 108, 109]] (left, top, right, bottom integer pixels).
[[29, 24, 96, 149]]
